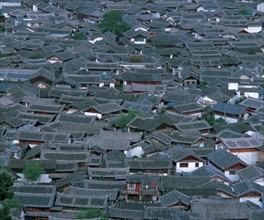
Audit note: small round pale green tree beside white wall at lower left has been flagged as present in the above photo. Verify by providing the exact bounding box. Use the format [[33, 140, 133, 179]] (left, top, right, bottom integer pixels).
[[23, 160, 43, 181]]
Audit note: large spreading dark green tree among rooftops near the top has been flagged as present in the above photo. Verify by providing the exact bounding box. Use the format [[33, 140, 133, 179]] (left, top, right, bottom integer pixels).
[[98, 11, 131, 38]]
